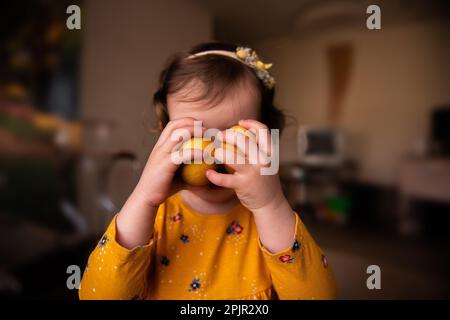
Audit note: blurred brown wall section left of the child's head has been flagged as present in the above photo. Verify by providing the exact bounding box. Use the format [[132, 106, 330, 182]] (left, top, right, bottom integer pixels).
[[80, 0, 212, 231]]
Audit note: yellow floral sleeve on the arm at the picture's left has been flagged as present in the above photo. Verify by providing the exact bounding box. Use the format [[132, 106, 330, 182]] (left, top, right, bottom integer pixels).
[[79, 216, 156, 300]]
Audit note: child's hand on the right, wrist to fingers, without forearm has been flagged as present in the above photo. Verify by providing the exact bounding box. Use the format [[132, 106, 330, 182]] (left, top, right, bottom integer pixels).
[[207, 120, 285, 213]]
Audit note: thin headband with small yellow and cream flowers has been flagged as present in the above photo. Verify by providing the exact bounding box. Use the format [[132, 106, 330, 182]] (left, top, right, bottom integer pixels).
[[188, 47, 275, 89]]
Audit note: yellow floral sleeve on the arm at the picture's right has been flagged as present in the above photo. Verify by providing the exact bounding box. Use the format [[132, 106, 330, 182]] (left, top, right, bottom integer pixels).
[[259, 214, 337, 300]]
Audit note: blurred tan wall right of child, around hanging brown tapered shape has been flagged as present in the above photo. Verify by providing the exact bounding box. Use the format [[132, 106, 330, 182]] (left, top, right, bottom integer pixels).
[[255, 22, 450, 185]]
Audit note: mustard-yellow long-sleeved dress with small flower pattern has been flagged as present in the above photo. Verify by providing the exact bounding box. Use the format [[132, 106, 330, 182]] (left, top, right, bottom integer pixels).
[[79, 194, 336, 300]]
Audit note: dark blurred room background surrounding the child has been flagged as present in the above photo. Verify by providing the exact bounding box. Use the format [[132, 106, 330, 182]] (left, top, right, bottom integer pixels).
[[0, 0, 450, 299]]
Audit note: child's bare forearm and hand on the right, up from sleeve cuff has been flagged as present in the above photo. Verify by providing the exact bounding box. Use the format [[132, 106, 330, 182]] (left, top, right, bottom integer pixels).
[[206, 120, 295, 253]]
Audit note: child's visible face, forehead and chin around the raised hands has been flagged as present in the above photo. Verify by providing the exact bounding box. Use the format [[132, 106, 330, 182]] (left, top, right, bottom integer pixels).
[[167, 80, 260, 202]]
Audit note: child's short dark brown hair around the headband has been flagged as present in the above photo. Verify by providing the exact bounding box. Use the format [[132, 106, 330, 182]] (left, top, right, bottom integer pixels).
[[153, 42, 285, 131]]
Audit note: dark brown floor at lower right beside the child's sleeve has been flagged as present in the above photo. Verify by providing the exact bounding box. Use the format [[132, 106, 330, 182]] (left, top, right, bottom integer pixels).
[[309, 224, 450, 299]]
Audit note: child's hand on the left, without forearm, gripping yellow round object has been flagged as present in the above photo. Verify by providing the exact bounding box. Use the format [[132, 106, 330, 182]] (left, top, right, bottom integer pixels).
[[135, 118, 201, 207]]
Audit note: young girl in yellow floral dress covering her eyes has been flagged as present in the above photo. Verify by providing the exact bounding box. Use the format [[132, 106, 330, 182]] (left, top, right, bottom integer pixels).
[[79, 43, 336, 300]]
